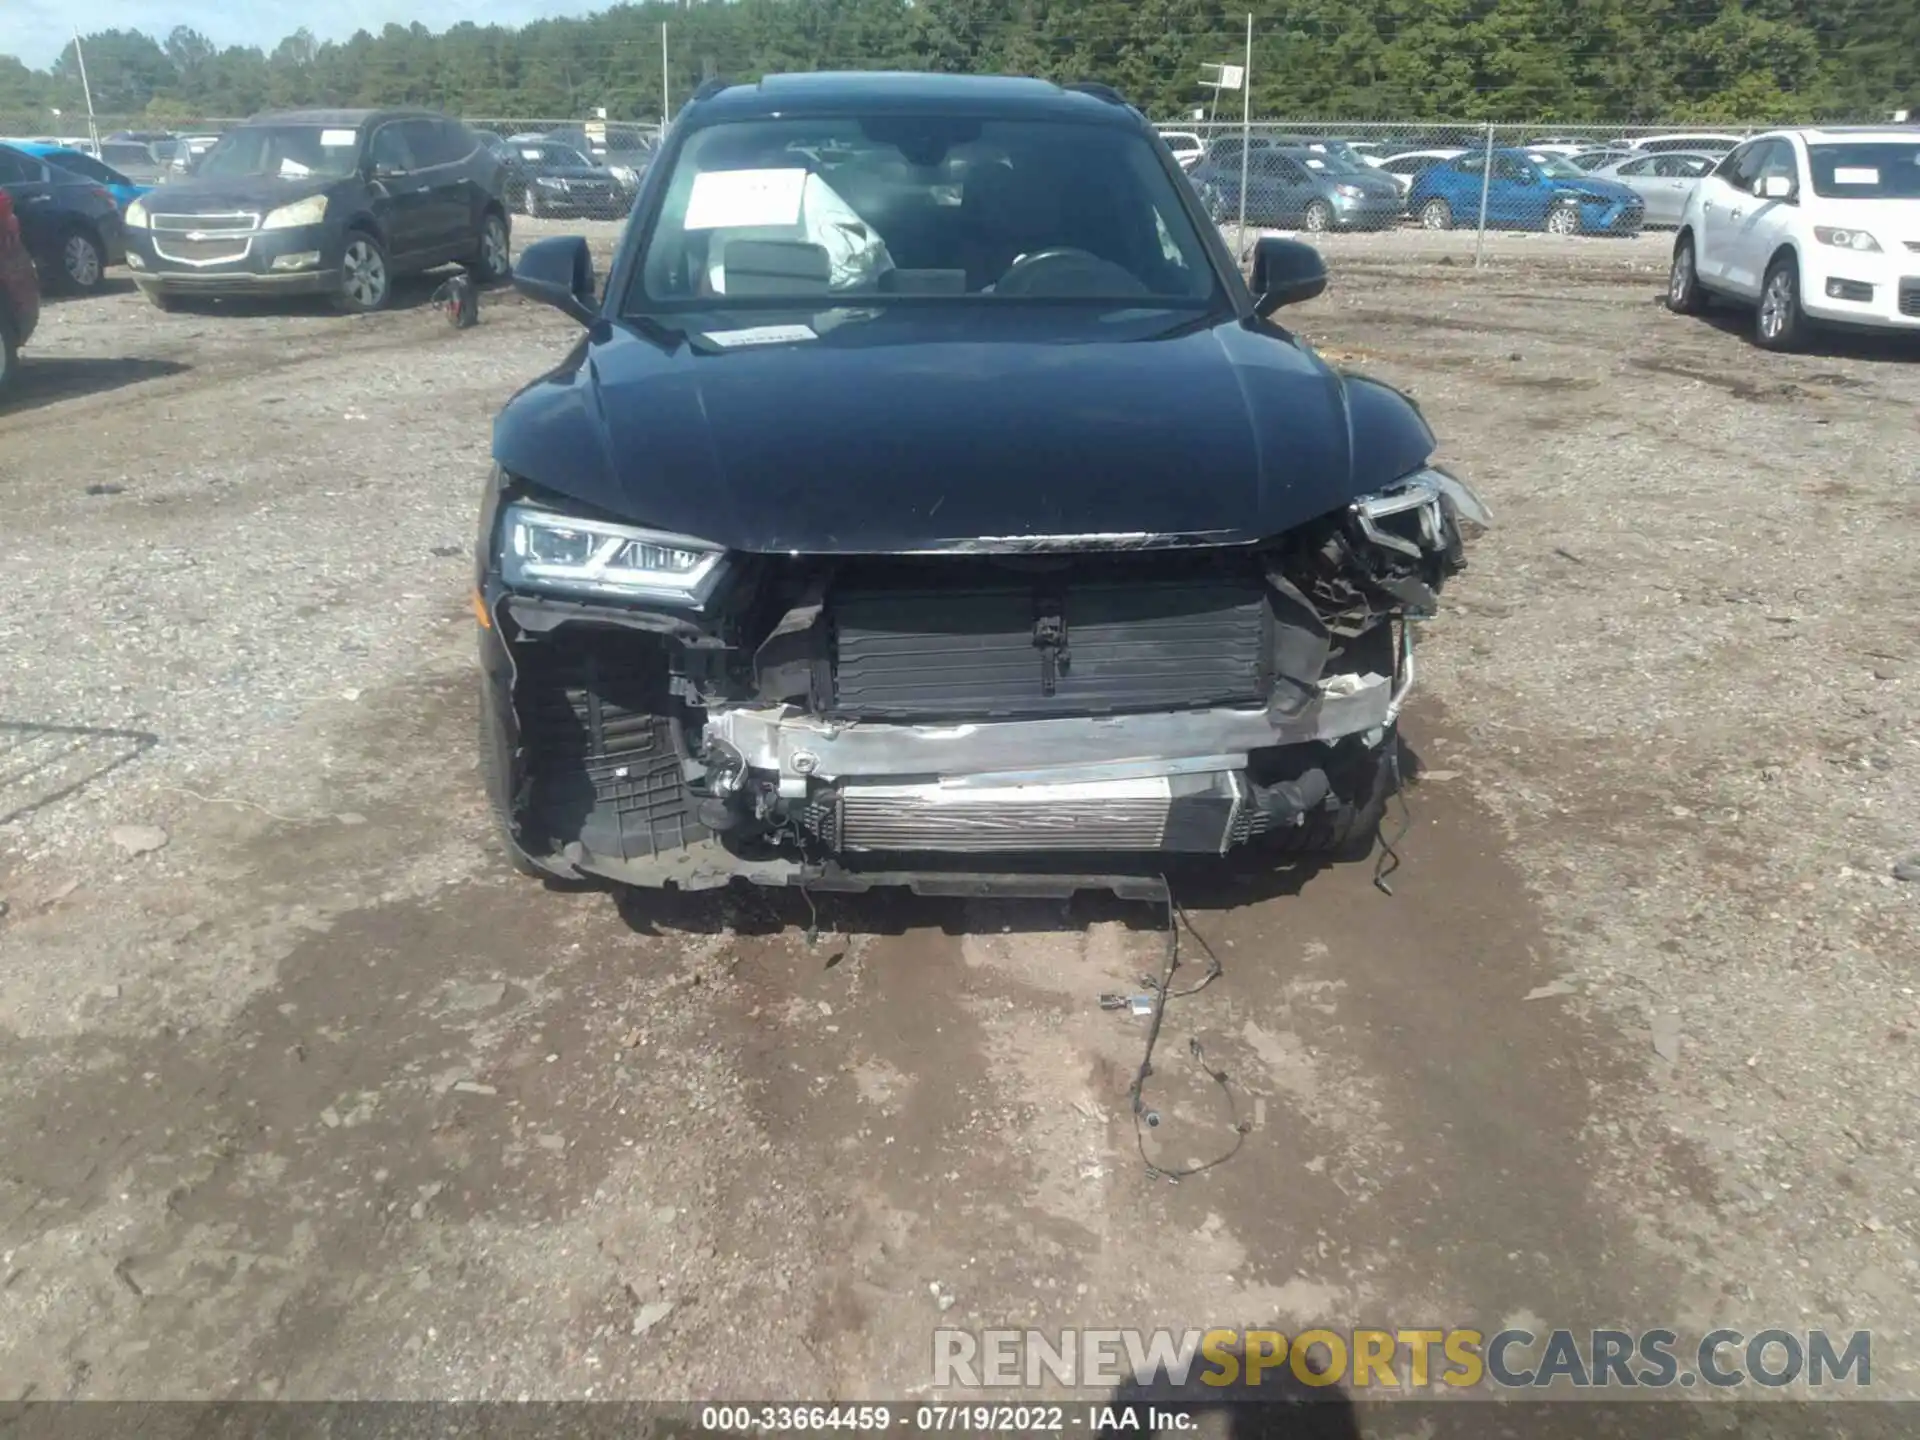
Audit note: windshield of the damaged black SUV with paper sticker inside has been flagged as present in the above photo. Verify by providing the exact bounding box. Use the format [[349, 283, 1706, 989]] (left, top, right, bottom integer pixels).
[[626, 115, 1215, 313]]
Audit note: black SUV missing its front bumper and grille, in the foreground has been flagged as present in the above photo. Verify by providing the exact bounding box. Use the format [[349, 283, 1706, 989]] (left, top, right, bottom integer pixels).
[[474, 75, 1486, 893]]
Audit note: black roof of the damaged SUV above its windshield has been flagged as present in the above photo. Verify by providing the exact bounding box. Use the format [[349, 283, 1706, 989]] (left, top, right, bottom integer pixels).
[[687, 71, 1144, 125]]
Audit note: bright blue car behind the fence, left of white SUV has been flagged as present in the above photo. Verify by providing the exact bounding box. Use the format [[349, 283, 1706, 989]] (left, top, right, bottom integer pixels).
[[1407, 150, 1645, 234]]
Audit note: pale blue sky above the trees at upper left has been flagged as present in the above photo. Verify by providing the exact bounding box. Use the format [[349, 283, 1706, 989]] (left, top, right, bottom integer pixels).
[[0, 0, 611, 69]]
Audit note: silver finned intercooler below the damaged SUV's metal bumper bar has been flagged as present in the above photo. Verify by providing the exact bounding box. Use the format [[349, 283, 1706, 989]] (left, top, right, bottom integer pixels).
[[828, 772, 1246, 854]]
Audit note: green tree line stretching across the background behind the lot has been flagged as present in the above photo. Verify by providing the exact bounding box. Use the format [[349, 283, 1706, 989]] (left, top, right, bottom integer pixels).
[[0, 0, 1920, 131]]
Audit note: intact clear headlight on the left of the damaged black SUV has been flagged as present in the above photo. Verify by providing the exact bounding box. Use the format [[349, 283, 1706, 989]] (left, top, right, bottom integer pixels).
[[499, 505, 726, 605]]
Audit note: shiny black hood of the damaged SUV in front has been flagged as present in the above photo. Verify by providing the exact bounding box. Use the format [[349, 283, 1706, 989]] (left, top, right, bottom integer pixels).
[[493, 305, 1432, 553]]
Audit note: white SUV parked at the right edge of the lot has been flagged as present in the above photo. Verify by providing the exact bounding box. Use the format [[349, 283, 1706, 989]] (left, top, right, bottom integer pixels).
[[1667, 125, 1920, 349]]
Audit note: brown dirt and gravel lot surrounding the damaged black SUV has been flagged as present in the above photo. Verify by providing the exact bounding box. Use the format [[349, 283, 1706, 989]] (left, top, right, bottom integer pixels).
[[0, 227, 1920, 1398]]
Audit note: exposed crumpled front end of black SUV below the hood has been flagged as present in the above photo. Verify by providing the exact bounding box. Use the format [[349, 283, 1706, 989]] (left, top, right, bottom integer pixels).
[[482, 468, 1488, 891]]
